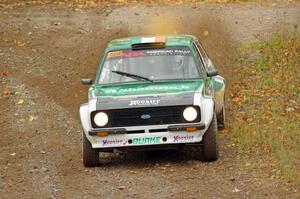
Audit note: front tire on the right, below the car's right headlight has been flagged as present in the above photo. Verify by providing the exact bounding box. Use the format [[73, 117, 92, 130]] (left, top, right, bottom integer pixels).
[[201, 113, 219, 162]]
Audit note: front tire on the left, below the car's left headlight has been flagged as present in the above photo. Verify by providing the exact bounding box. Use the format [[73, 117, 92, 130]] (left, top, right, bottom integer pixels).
[[82, 132, 100, 167]]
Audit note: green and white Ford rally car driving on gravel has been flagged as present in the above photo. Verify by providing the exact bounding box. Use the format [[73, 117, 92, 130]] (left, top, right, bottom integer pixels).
[[80, 35, 225, 167]]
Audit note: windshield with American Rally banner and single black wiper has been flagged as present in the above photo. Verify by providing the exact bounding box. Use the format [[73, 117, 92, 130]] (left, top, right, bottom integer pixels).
[[98, 47, 202, 84]]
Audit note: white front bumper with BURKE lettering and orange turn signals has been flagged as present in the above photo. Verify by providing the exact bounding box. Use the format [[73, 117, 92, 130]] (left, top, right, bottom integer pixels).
[[86, 123, 205, 149]]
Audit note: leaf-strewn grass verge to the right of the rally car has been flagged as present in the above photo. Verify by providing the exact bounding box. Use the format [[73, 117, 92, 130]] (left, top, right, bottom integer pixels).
[[229, 31, 300, 185]]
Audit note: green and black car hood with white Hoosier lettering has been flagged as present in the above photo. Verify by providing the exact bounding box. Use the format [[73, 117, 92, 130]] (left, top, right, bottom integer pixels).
[[89, 80, 203, 110]]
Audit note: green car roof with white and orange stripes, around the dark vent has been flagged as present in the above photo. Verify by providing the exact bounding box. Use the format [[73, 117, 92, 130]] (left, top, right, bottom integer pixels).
[[105, 34, 197, 52]]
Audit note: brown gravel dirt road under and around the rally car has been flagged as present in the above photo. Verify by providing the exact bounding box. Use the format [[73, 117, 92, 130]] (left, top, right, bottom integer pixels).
[[0, 3, 300, 199]]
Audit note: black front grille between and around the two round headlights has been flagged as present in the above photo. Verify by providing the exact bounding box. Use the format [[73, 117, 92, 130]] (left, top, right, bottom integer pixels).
[[91, 105, 201, 128]]
